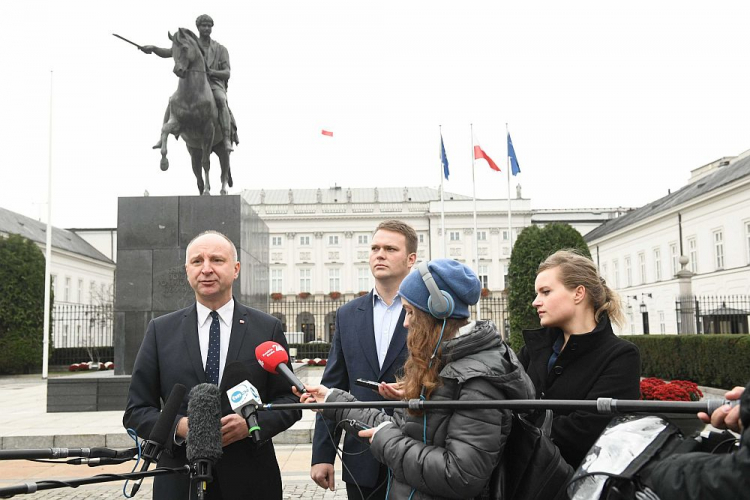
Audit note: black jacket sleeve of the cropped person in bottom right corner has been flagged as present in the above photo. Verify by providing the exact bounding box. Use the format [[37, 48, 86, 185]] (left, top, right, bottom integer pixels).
[[647, 384, 750, 500]]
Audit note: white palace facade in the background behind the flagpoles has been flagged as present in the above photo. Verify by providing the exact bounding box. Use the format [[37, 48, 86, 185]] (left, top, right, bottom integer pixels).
[[242, 187, 624, 296]]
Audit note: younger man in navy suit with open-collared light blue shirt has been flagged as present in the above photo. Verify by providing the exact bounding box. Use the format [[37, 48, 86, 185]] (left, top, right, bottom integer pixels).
[[310, 220, 418, 500]]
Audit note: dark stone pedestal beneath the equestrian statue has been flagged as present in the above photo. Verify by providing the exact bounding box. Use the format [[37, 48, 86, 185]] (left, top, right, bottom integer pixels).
[[114, 195, 269, 375]]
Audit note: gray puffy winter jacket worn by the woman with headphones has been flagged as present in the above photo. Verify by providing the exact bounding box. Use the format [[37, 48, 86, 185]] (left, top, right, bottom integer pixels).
[[323, 321, 534, 500]]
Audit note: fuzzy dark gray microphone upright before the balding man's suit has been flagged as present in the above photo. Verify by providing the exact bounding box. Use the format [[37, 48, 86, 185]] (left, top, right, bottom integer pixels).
[[186, 384, 222, 500]]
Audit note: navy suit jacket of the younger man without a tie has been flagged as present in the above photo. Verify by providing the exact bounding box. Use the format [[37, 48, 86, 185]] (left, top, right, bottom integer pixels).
[[312, 292, 408, 488]]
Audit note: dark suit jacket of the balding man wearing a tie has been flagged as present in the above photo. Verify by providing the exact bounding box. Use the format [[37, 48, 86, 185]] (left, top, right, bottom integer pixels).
[[123, 300, 302, 500]]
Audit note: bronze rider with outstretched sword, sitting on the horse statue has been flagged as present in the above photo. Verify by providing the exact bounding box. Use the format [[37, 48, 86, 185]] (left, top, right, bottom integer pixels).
[[140, 14, 239, 151]]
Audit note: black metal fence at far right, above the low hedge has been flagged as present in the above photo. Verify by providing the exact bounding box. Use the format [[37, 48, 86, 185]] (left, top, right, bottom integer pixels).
[[675, 295, 750, 334]]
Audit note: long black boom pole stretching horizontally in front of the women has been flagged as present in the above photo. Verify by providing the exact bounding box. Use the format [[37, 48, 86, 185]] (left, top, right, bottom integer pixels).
[[258, 398, 739, 415]]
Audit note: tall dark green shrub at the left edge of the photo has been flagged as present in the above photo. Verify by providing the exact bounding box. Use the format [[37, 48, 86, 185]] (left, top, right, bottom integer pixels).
[[0, 234, 52, 373]]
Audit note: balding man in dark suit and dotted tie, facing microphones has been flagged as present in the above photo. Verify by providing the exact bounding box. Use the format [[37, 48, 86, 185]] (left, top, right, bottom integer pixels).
[[123, 231, 302, 500]]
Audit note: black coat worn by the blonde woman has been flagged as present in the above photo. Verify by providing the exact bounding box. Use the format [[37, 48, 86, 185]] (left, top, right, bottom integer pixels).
[[518, 315, 641, 469]]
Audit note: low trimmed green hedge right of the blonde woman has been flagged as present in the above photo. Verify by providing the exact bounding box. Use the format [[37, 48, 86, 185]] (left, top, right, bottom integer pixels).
[[622, 335, 750, 389]]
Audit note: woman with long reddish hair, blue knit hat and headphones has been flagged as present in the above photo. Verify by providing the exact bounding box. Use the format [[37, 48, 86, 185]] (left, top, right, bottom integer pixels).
[[301, 259, 533, 500]]
